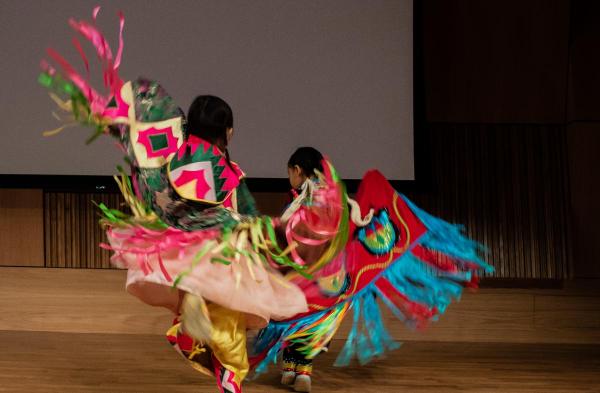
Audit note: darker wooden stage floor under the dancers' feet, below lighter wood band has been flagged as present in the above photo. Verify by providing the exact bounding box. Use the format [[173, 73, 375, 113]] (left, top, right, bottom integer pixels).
[[0, 330, 600, 393]]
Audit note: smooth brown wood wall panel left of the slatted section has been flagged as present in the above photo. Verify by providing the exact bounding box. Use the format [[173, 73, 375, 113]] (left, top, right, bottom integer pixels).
[[0, 189, 44, 266]]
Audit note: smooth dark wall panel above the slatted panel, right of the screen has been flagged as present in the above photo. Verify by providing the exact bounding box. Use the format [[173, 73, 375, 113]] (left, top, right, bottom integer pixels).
[[423, 0, 569, 123]]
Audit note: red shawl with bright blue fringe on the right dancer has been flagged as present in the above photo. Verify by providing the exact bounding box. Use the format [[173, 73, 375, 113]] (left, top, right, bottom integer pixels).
[[251, 170, 493, 373]]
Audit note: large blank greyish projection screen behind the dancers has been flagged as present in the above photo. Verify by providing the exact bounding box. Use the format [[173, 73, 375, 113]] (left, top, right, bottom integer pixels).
[[0, 0, 414, 180]]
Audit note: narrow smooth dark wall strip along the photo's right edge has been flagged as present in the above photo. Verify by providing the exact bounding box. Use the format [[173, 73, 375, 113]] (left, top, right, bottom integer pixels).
[[568, 0, 600, 278]]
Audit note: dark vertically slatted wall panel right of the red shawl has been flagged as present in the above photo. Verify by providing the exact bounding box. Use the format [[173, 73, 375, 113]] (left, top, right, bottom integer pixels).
[[408, 123, 571, 279]]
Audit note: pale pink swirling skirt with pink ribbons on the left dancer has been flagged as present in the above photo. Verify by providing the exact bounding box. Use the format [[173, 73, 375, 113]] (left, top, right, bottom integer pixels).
[[106, 227, 308, 329]]
